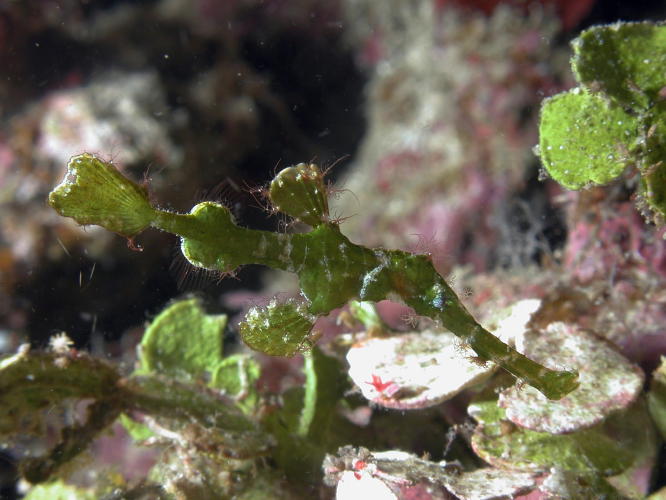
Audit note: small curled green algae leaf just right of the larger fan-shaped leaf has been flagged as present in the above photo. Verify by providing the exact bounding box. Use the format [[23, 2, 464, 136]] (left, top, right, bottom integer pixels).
[[209, 354, 261, 414]]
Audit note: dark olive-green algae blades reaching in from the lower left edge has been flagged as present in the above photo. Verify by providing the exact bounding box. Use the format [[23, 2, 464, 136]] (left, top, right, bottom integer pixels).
[[0, 332, 274, 483]]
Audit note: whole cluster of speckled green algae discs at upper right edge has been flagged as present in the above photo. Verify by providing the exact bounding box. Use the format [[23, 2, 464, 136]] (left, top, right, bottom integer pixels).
[[539, 22, 666, 224]]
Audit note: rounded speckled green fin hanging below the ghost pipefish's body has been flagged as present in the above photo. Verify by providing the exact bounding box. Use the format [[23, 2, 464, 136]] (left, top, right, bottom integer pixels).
[[239, 300, 314, 356]]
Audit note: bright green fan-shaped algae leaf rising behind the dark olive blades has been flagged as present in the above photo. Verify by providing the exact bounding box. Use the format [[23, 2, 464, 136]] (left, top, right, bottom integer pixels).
[[138, 299, 227, 380]]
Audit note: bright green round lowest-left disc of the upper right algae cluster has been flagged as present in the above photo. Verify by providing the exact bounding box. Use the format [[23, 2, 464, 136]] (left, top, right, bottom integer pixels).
[[539, 89, 638, 189]]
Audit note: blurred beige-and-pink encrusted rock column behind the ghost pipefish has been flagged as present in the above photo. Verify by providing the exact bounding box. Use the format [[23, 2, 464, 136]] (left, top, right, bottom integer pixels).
[[333, 1, 560, 273]]
